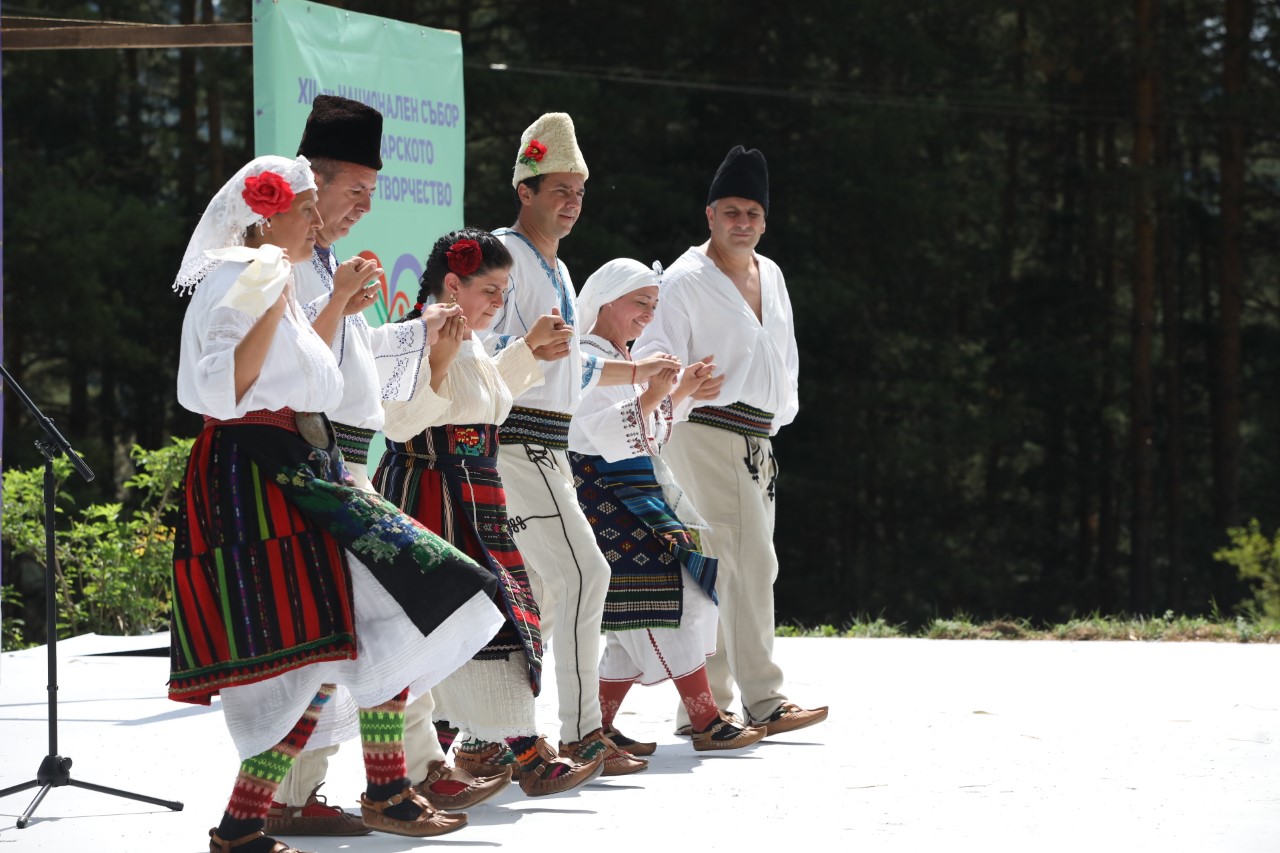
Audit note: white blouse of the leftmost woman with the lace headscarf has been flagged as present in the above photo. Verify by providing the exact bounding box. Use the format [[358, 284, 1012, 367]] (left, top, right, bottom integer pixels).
[[178, 263, 343, 420]]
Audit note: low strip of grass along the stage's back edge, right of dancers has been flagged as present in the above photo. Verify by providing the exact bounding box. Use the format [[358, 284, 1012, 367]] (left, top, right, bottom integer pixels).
[[777, 611, 1280, 643]]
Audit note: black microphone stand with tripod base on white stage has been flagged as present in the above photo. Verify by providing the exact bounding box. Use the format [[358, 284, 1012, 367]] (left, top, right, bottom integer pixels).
[[0, 364, 182, 829]]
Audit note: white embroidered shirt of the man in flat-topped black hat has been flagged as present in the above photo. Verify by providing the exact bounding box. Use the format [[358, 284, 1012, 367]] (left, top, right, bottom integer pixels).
[[293, 246, 426, 429]]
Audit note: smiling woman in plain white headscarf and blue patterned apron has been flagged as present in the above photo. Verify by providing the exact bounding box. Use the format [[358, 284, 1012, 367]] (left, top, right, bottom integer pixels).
[[568, 259, 764, 754]]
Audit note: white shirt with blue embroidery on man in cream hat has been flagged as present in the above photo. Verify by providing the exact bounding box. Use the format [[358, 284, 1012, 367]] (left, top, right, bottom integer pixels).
[[483, 228, 603, 415]]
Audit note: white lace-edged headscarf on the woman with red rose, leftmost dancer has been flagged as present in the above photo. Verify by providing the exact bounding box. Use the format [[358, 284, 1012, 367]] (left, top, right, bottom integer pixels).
[[173, 154, 316, 296]]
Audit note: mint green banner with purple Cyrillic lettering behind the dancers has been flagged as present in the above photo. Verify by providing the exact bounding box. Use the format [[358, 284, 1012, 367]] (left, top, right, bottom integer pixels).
[[253, 0, 466, 318]]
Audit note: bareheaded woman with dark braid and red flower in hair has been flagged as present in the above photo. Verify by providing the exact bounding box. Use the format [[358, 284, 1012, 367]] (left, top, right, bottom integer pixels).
[[374, 228, 603, 797]]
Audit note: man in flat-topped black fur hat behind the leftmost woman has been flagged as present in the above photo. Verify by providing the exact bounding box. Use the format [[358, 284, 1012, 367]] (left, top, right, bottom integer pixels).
[[268, 95, 507, 835]]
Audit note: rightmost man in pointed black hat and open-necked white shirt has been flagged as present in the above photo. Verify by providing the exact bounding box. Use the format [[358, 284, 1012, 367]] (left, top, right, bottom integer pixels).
[[634, 146, 827, 735]]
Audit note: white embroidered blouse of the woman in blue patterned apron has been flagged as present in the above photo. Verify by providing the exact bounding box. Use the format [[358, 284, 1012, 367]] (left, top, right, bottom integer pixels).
[[568, 335, 673, 462]]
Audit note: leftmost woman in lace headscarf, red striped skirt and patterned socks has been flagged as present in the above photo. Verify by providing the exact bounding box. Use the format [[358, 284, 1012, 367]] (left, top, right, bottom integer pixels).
[[169, 156, 502, 853]]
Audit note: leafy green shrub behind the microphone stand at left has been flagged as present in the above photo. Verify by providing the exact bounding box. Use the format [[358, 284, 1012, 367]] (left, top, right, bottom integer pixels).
[[0, 438, 192, 648]]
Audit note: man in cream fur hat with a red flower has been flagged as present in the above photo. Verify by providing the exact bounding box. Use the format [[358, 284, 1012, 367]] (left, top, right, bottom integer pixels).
[[481, 113, 672, 775]]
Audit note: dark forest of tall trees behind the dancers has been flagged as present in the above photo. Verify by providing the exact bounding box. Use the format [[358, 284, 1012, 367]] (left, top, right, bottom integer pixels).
[[3, 0, 1280, 637]]
